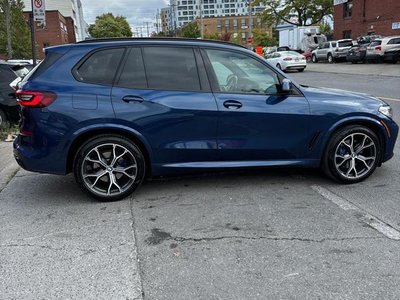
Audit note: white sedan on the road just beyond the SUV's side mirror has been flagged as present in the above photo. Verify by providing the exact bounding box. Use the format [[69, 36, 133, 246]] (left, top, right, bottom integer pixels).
[[268, 51, 307, 72]]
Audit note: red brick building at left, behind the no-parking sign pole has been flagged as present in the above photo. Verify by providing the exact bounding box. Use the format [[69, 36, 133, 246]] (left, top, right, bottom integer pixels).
[[24, 10, 76, 59]]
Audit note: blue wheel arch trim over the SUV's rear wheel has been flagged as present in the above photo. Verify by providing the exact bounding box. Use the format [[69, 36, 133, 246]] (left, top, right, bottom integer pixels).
[[66, 126, 152, 177]]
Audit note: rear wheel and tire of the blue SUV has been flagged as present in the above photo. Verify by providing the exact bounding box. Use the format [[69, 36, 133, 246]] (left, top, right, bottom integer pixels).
[[74, 135, 145, 201]]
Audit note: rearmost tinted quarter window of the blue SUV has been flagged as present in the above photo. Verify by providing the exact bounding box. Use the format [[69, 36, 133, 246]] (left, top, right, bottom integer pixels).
[[74, 48, 125, 85]]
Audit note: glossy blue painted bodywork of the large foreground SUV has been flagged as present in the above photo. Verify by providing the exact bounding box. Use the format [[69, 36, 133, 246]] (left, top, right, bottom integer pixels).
[[14, 39, 398, 176]]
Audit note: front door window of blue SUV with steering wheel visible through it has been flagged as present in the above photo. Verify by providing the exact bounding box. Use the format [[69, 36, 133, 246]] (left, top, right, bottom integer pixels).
[[206, 49, 279, 94]]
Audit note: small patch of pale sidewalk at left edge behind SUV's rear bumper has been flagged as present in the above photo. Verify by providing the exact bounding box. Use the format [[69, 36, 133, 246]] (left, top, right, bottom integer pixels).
[[0, 141, 19, 191]]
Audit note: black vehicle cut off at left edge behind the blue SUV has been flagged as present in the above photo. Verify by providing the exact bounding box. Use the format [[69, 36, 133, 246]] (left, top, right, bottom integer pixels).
[[0, 62, 32, 128]]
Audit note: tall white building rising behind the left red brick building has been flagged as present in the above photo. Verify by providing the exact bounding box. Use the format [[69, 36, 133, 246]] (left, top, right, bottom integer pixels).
[[24, 0, 89, 41]]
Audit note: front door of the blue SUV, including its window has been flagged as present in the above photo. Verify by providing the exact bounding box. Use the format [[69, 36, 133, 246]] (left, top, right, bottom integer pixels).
[[203, 49, 309, 161]]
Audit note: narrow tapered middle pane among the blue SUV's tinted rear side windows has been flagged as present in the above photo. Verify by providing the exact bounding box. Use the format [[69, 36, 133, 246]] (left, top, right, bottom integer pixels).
[[116, 48, 147, 89]]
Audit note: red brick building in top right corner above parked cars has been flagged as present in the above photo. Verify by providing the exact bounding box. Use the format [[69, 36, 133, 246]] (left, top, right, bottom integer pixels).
[[333, 0, 400, 39]]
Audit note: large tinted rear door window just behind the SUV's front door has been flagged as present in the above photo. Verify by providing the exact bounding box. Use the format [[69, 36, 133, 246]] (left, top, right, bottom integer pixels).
[[143, 47, 200, 91]]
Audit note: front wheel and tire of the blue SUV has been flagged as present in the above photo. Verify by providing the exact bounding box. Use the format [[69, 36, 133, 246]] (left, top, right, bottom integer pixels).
[[322, 125, 381, 184]]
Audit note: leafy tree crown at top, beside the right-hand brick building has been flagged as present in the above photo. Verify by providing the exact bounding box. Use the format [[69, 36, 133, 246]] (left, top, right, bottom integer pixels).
[[255, 0, 333, 26]]
